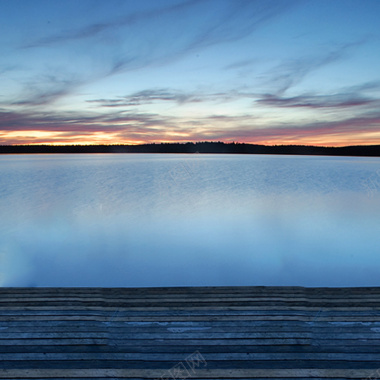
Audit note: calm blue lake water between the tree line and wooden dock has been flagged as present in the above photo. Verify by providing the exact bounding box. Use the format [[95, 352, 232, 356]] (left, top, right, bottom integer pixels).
[[0, 154, 380, 286]]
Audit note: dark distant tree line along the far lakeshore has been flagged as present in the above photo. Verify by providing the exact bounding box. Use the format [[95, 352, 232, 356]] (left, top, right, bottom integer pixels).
[[0, 141, 380, 157]]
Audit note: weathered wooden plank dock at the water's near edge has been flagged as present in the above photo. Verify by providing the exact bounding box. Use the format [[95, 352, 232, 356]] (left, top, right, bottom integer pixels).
[[0, 287, 380, 380]]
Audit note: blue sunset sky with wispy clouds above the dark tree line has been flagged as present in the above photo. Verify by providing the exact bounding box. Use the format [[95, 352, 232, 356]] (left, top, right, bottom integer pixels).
[[0, 0, 380, 146]]
